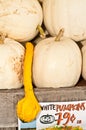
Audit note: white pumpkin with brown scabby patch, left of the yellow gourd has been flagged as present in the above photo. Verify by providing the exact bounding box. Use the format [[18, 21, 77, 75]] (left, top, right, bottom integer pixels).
[[0, 38, 25, 89]]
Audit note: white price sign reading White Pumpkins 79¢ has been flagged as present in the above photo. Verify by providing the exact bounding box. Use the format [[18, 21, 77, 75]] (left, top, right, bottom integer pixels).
[[36, 101, 86, 130]]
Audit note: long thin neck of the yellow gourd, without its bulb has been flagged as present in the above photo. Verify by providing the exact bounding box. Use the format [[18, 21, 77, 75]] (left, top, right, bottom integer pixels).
[[23, 43, 34, 96]]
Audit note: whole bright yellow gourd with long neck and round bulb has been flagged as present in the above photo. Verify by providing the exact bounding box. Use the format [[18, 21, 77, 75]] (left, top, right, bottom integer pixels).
[[17, 43, 41, 122]]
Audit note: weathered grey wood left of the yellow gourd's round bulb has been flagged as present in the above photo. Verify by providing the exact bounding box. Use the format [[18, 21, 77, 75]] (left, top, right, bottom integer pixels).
[[0, 90, 21, 128]]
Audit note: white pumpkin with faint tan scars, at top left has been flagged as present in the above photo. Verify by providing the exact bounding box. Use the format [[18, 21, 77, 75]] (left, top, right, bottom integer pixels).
[[0, 0, 43, 42]]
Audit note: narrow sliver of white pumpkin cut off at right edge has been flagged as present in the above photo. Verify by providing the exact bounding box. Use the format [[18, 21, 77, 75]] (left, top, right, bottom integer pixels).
[[81, 45, 86, 80]]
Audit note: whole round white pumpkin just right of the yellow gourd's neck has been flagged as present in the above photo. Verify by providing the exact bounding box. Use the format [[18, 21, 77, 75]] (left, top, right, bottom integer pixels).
[[32, 37, 82, 88]]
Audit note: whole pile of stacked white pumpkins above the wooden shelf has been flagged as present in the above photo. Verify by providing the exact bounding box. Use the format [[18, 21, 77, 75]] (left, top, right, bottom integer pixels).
[[0, 0, 86, 89]]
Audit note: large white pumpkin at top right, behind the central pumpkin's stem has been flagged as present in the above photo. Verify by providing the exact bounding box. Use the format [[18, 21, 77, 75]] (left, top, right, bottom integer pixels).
[[43, 0, 86, 41]]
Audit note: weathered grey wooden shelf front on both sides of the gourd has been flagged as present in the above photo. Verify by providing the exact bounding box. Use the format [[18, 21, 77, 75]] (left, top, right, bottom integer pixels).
[[0, 77, 86, 128]]
